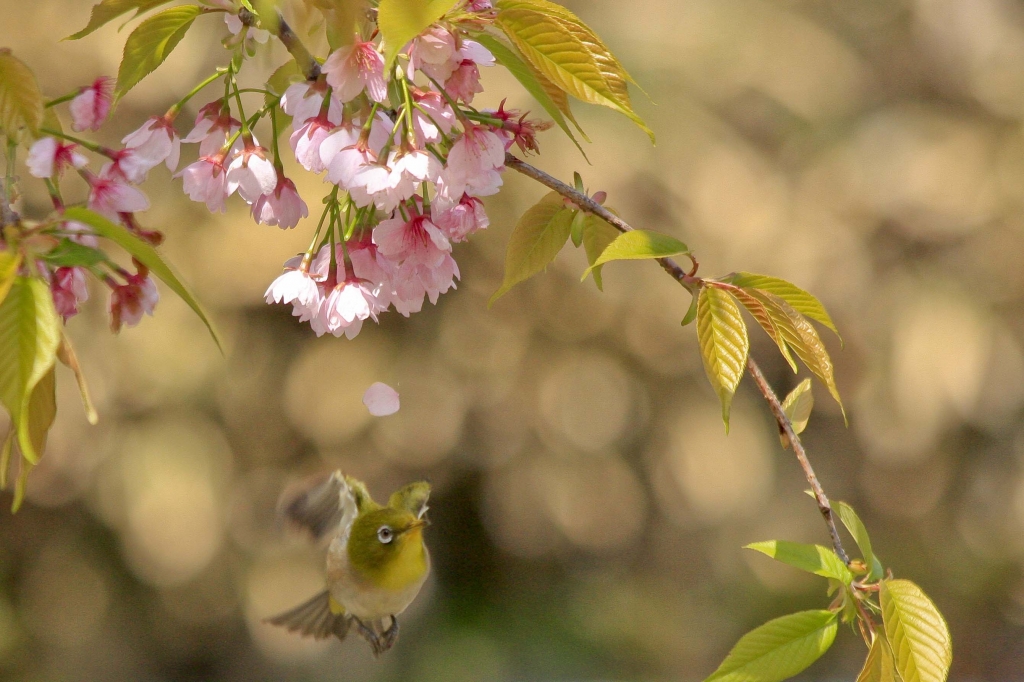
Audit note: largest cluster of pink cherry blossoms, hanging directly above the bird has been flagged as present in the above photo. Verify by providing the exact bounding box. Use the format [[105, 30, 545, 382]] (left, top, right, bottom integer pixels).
[[179, 1, 545, 338]]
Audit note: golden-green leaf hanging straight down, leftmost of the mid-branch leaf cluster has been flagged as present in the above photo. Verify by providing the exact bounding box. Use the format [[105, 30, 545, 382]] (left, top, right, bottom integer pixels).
[[697, 286, 750, 433]]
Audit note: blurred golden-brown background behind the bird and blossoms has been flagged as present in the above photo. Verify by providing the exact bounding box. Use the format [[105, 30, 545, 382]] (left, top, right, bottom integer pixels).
[[0, 0, 1024, 682]]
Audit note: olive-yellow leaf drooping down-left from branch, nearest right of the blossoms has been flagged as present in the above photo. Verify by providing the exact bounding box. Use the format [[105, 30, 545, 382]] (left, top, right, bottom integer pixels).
[[487, 191, 572, 306]]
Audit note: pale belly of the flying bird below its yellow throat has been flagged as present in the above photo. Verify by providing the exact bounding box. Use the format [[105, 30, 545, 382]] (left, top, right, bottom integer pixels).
[[327, 545, 430, 621]]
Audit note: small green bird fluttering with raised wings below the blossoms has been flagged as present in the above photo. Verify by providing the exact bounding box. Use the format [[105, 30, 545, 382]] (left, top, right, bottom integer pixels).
[[266, 471, 430, 655]]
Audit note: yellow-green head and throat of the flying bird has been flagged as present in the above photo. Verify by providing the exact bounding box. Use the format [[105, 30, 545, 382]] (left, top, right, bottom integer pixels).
[[348, 482, 430, 590]]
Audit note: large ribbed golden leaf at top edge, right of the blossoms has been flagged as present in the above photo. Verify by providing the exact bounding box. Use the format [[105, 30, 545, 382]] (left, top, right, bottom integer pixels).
[[496, 0, 654, 142]]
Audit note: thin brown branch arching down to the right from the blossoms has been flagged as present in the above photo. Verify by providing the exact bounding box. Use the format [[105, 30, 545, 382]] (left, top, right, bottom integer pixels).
[[505, 154, 850, 564]]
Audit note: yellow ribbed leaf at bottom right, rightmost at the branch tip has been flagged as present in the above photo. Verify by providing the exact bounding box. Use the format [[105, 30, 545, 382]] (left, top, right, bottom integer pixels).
[[879, 580, 953, 682]]
